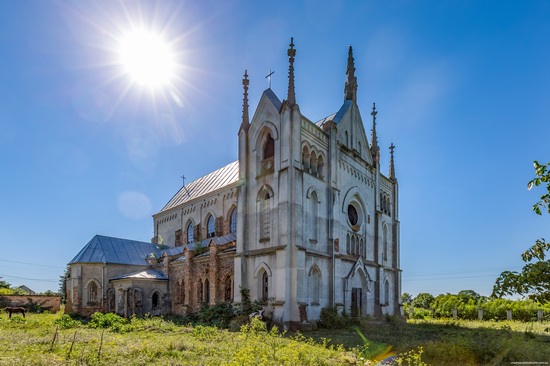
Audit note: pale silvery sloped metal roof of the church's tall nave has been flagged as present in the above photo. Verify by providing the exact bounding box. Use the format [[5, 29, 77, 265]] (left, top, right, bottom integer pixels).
[[159, 160, 239, 213]]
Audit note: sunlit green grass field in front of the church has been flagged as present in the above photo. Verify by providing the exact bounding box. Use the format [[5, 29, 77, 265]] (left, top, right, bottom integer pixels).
[[0, 313, 550, 366]]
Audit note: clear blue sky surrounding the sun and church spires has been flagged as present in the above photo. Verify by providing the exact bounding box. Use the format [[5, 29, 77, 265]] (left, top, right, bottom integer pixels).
[[0, 0, 550, 295]]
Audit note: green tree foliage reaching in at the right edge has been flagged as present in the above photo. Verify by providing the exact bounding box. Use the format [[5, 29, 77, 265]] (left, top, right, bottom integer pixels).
[[492, 161, 550, 303]]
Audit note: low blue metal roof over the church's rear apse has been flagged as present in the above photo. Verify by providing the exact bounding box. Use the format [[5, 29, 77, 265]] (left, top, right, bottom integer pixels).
[[69, 235, 166, 266]]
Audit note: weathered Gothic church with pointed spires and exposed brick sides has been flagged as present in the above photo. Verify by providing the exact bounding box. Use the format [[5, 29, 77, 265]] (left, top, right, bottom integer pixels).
[[66, 40, 402, 329]]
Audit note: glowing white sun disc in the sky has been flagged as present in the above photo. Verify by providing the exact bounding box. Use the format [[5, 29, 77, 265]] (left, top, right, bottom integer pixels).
[[118, 29, 176, 88]]
